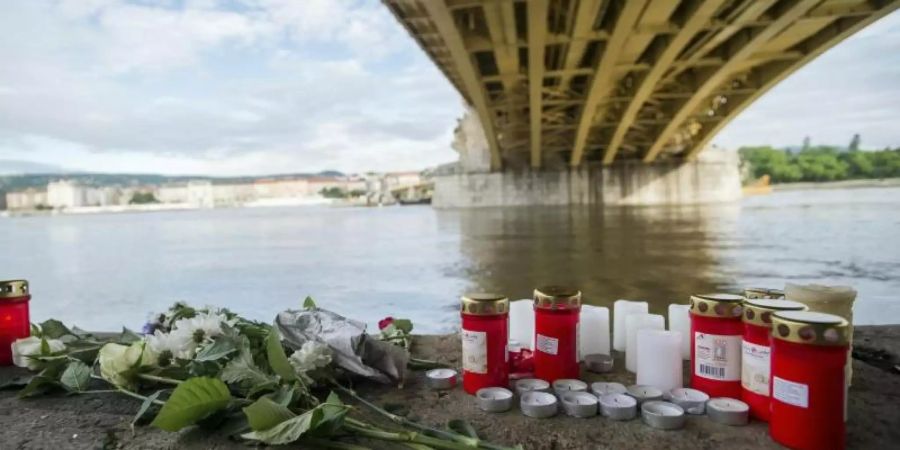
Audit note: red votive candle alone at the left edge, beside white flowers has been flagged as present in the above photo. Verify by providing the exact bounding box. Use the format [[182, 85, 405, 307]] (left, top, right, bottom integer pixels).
[[0, 280, 31, 366]]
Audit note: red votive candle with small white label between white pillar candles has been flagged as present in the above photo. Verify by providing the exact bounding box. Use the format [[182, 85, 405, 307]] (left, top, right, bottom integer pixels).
[[534, 286, 581, 383]]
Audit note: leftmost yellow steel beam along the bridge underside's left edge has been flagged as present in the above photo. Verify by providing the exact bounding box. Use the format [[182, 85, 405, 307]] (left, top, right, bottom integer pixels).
[[422, 0, 503, 170]]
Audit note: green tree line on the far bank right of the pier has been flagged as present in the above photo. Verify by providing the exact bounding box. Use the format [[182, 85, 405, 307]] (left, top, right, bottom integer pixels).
[[738, 146, 900, 183]]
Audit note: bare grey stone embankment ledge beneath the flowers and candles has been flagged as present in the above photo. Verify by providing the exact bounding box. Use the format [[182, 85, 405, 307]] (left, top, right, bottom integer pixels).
[[0, 325, 900, 450]]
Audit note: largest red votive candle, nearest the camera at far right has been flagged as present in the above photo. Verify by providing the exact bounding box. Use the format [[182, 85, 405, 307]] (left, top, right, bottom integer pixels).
[[769, 311, 850, 450]]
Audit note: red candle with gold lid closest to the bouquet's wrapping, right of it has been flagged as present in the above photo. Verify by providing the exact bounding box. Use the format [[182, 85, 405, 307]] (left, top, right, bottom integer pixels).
[[460, 293, 509, 395]]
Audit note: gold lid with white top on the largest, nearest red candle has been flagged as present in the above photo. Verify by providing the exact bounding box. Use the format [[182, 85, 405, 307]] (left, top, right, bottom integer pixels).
[[772, 311, 850, 346]]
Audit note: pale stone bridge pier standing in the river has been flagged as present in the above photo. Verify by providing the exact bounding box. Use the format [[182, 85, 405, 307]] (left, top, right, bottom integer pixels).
[[432, 151, 741, 208]]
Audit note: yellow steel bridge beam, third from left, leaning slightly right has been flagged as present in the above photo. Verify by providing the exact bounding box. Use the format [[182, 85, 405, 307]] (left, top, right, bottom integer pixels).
[[569, 0, 647, 167]]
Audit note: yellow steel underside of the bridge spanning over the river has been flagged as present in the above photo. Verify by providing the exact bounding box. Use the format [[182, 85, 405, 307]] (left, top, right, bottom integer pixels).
[[382, 0, 900, 170]]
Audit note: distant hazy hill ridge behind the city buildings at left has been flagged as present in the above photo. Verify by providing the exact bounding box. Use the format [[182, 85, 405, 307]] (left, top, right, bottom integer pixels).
[[0, 168, 344, 192]]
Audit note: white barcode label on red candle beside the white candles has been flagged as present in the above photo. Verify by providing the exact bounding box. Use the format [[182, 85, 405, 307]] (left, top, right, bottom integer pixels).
[[694, 332, 743, 381]]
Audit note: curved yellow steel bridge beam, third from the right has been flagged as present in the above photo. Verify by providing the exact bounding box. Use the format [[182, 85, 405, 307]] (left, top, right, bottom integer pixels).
[[603, 0, 725, 164]]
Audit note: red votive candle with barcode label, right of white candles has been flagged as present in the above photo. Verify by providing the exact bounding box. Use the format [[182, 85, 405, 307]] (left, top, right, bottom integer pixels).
[[690, 294, 744, 398]]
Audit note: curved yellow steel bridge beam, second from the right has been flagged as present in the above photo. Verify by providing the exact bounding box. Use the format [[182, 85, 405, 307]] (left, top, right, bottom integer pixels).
[[643, 0, 819, 163]]
